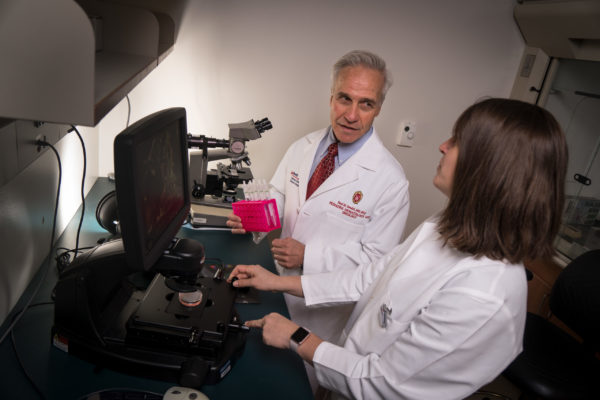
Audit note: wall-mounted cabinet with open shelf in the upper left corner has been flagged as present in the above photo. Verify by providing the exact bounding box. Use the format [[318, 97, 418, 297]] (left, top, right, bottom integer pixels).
[[0, 0, 182, 126]]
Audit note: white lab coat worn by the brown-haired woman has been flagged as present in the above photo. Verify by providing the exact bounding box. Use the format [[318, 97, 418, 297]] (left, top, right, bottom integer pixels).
[[302, 217, 527, 400]]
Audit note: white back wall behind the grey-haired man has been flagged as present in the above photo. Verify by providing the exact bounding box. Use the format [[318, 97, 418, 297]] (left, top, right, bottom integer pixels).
[[98, 0, 524, 233]]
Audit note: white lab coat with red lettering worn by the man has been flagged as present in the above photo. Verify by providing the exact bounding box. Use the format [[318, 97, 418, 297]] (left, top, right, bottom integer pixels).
[[271, 129, 409, 340]]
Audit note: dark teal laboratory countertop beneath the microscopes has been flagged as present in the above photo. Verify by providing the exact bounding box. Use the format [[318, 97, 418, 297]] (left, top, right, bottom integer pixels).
[[0, 178, 313, 400]]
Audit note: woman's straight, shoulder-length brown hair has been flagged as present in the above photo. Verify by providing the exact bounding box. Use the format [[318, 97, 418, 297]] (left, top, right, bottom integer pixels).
[[438, 99, 567, 263]]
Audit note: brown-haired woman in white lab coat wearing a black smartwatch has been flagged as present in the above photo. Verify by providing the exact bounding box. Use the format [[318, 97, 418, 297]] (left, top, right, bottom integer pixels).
[[230, 99, 567, 399]]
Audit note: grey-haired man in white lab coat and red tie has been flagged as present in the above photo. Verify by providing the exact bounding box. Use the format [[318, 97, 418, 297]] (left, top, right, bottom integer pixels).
[[228, 51, 409, 386]]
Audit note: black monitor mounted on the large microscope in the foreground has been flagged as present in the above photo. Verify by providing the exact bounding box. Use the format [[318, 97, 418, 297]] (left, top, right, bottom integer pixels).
[[114, 108, 190, 271]]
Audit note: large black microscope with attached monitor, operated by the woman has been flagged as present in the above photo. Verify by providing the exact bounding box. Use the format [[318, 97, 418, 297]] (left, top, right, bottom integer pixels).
[[52, 108, 248, 388]]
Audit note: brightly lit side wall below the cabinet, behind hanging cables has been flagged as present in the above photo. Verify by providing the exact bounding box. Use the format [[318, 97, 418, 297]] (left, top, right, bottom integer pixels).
[[0, 121, 98, 323]]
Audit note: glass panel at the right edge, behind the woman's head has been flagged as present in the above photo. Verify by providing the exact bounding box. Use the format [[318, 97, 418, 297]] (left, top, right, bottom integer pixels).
[[545, 60, 600, 262]]
